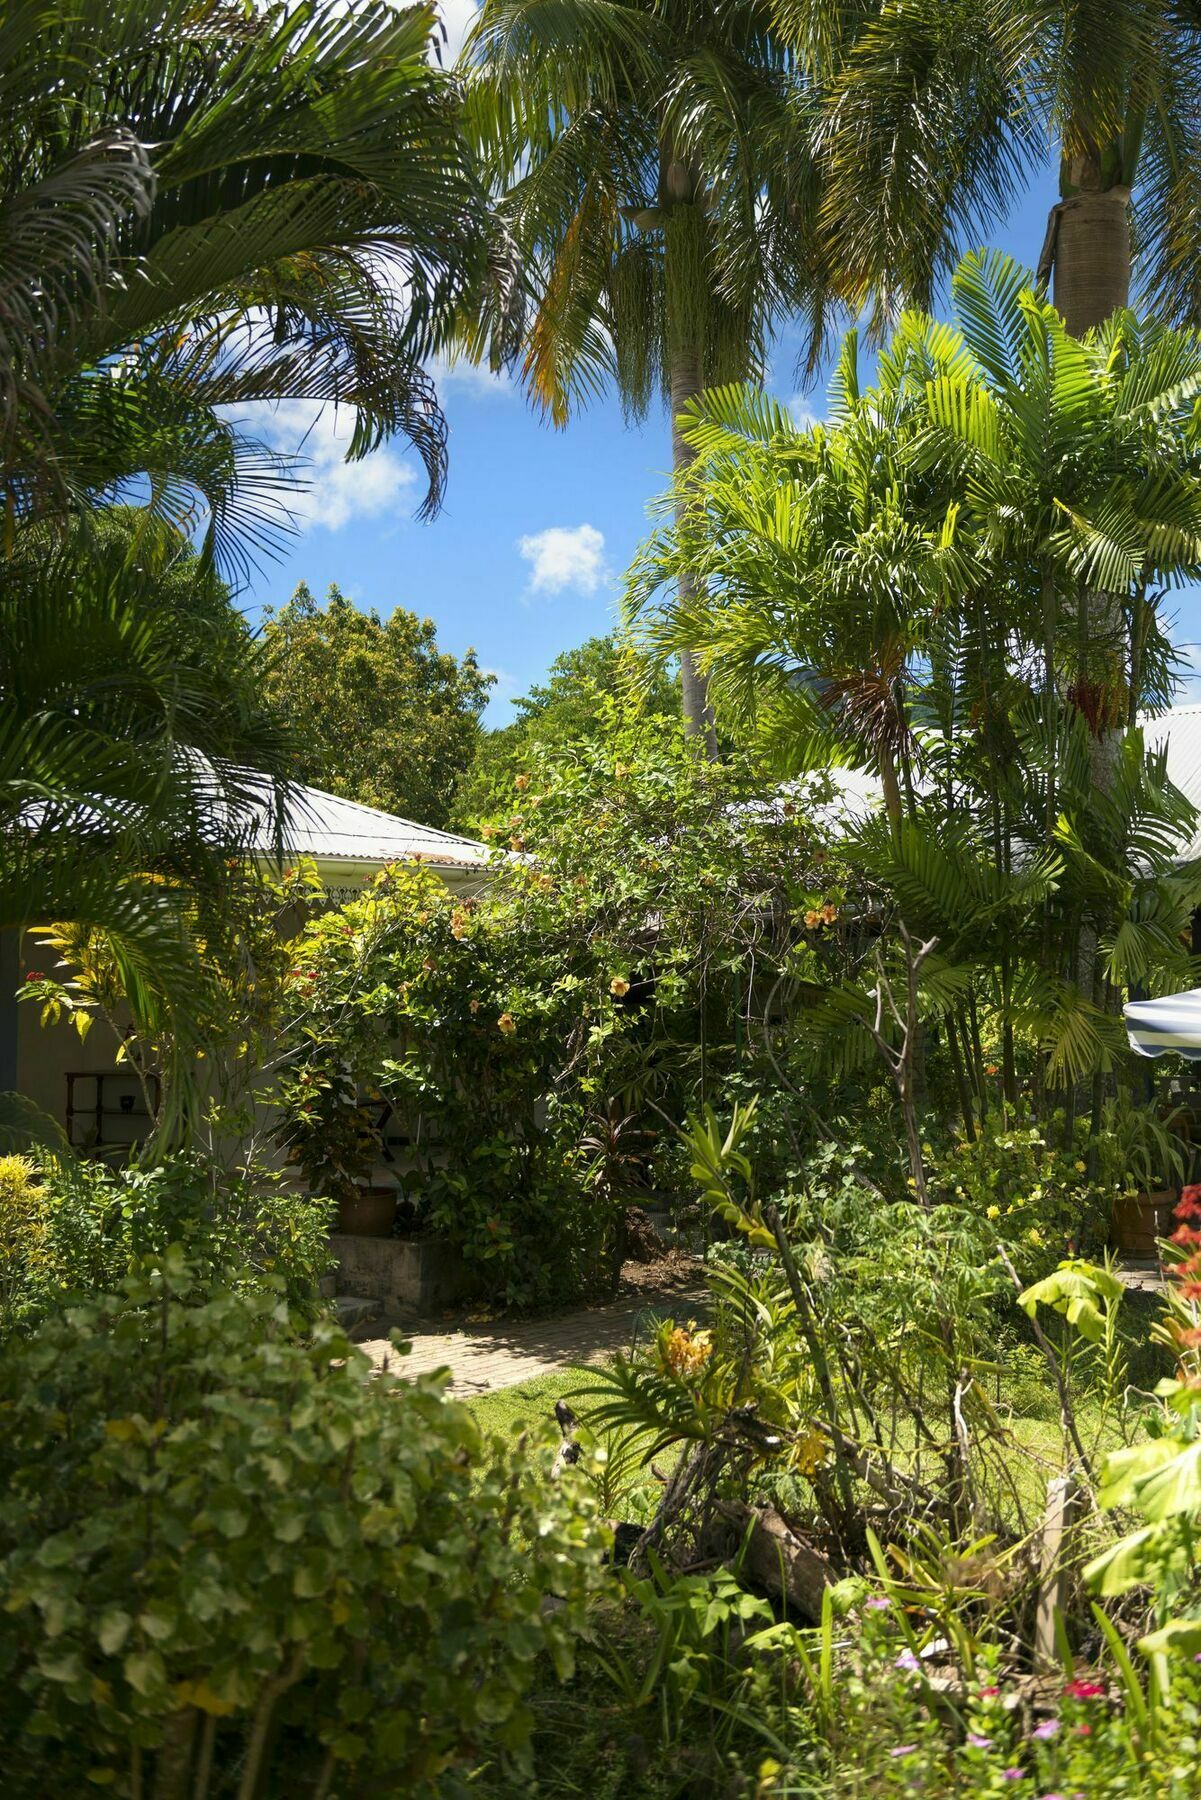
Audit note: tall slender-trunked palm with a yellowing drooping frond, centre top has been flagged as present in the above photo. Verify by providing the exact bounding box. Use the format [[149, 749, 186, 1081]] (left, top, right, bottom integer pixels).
[[463, 0, 828, 734]]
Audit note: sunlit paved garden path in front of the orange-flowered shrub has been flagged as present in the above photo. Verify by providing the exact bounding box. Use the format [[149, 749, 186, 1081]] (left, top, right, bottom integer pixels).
[[357, 1258, 704, 1399]]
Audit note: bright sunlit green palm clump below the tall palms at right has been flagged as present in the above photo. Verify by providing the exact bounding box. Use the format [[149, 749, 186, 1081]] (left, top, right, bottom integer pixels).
[[632, 254, 1201, 1103]]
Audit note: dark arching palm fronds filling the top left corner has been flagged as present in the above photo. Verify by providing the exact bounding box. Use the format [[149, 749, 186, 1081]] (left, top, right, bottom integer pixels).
[[0, 0, 490, 553]]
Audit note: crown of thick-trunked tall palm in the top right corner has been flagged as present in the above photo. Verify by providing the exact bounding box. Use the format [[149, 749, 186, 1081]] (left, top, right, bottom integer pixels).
[[780, 0, 1201, 335]]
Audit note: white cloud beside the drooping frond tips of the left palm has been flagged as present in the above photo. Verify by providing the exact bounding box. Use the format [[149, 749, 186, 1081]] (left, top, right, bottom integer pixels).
[[254, 400, 418, 531]]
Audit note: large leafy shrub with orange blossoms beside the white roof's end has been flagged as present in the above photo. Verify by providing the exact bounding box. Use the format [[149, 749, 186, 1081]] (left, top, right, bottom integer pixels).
[[283, 730, 835, 1303]]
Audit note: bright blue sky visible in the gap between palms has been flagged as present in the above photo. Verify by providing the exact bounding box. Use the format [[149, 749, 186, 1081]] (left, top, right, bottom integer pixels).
[[243, 114, 1201, 725]]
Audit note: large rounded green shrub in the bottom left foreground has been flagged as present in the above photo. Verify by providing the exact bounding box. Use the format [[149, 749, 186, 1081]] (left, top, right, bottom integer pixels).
[[0, 1249, 603, 1800]]
